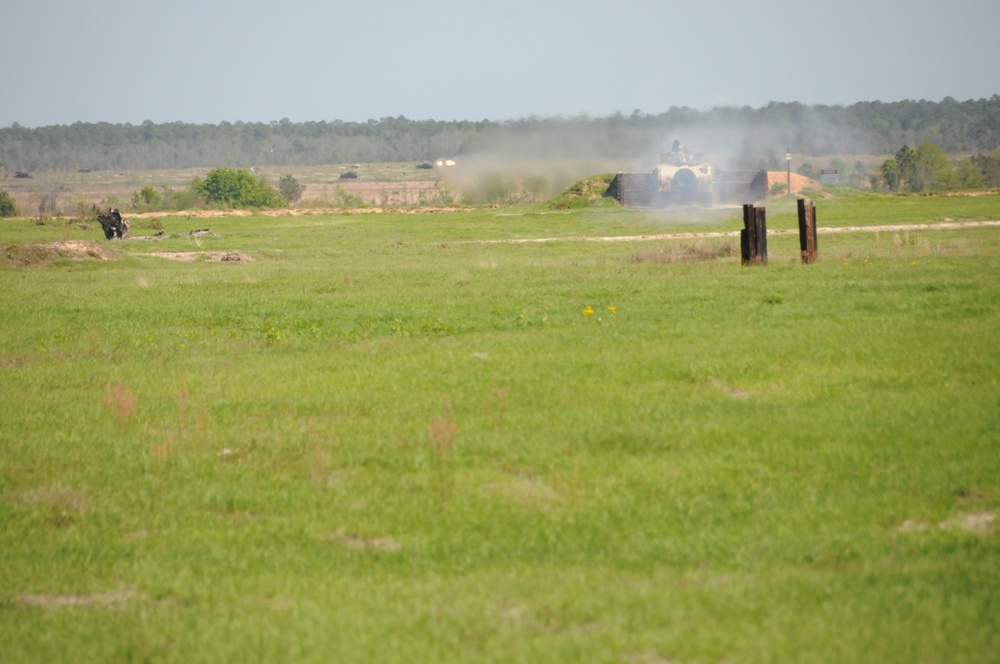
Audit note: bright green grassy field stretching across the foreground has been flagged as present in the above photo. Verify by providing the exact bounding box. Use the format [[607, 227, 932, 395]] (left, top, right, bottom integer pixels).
[[0, 195, 1000, 664]]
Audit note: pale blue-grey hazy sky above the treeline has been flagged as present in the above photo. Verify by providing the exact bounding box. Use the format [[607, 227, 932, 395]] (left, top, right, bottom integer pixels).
[[0, 0, 1000, 127]]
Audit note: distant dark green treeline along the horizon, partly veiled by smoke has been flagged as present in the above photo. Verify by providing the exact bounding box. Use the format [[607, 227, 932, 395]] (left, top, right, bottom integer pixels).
[[0, 95, 1000, 172]]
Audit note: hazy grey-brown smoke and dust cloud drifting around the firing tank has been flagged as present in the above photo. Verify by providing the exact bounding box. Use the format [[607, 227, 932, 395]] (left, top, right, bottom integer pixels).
[[439, 103, 871, 203]]
